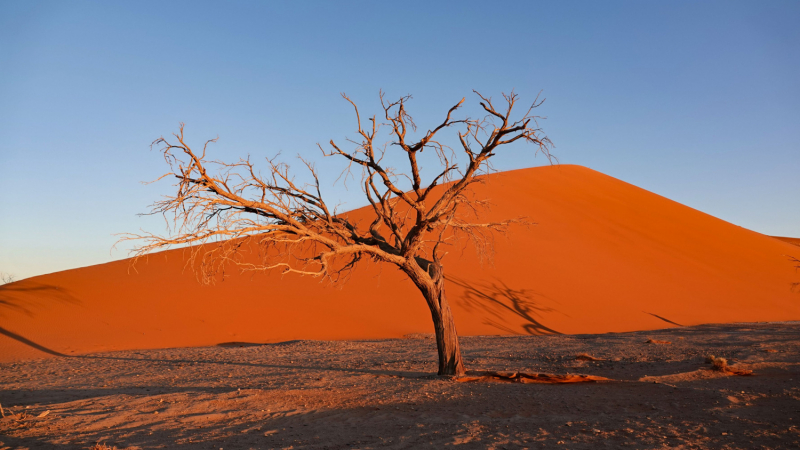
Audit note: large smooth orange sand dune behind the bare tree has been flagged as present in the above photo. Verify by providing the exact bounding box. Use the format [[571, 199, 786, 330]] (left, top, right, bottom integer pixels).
[[0, 165, 800, 361]]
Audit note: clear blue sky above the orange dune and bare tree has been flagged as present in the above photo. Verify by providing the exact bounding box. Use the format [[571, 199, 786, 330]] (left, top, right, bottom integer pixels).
[[0, 0, 800, 279]]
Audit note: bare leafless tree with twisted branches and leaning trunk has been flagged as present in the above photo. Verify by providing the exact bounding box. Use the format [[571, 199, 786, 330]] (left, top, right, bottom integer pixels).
[[123, 92, 552, 376]]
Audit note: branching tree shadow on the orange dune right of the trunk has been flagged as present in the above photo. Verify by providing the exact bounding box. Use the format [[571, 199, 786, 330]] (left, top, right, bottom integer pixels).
[[447, 277, 561, 335]]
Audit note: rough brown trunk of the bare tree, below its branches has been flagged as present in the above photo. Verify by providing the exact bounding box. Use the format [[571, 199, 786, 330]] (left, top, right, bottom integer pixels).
[[412, 262, 466, 376]]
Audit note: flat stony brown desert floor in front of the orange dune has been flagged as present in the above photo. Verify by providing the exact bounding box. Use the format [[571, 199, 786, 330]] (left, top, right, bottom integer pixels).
[[0, 322, 800, 449]]
